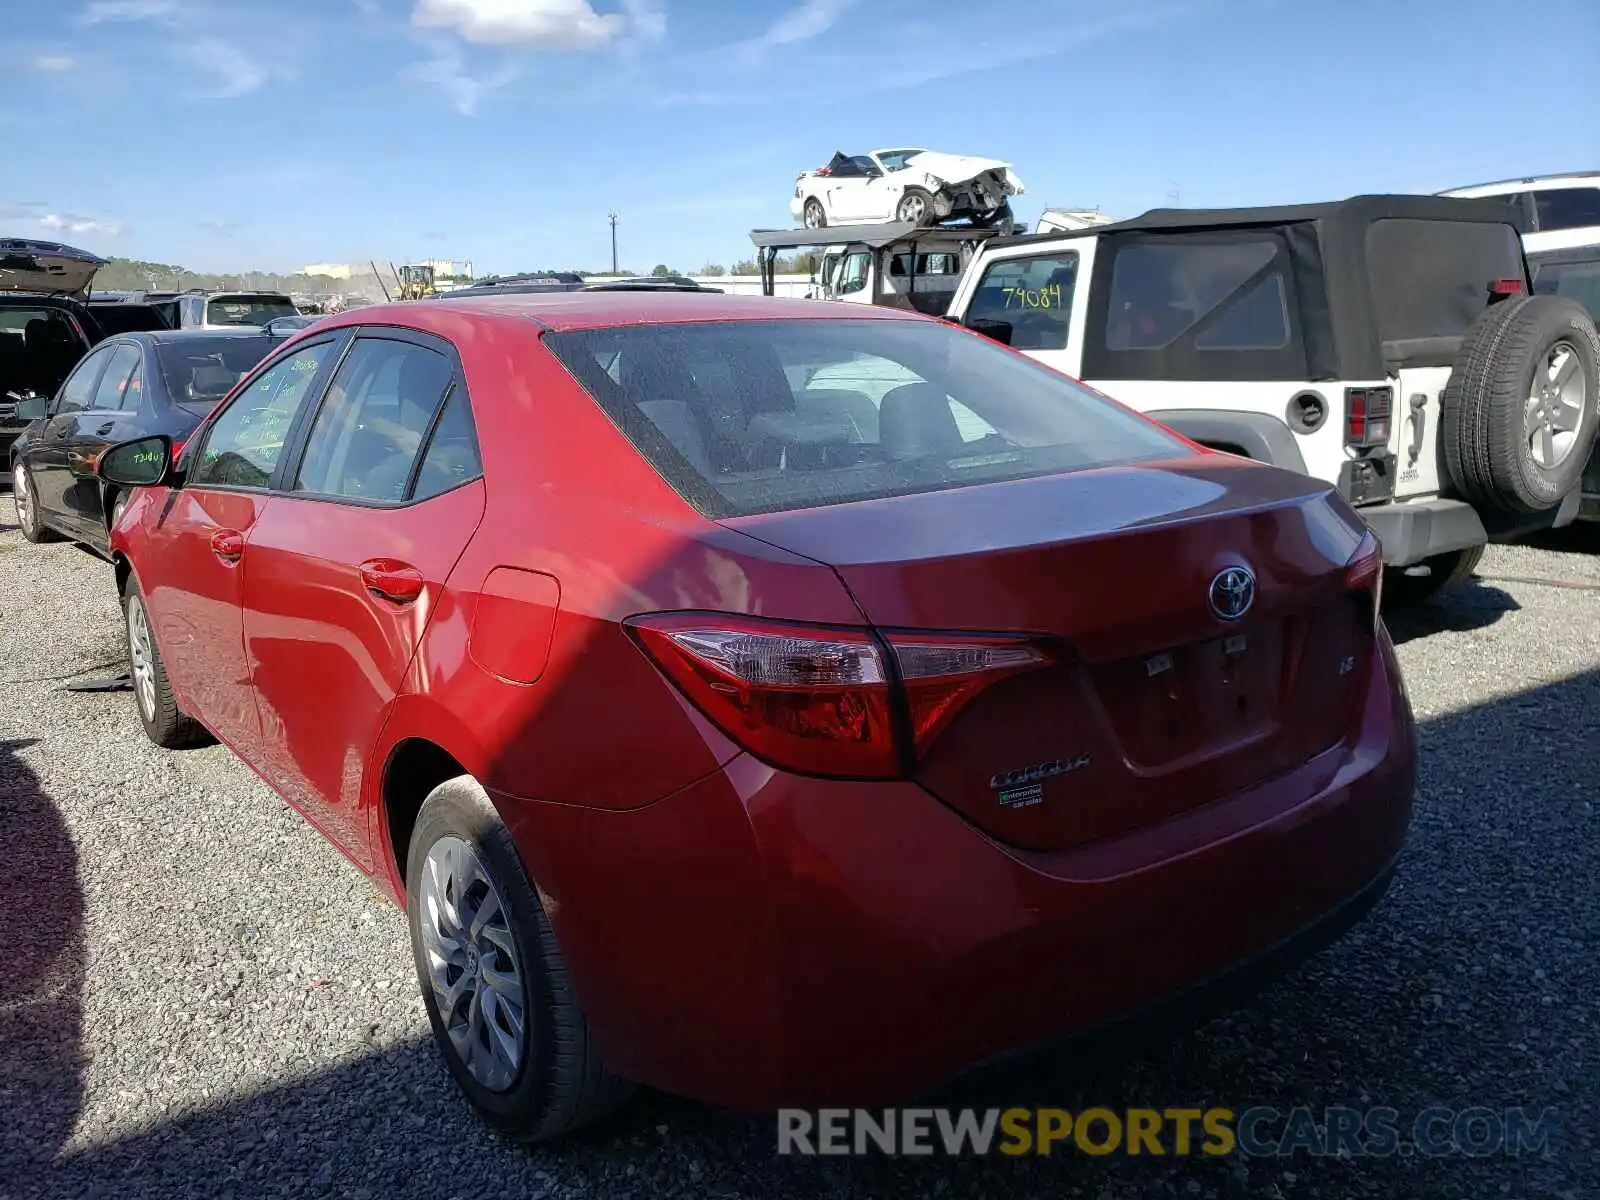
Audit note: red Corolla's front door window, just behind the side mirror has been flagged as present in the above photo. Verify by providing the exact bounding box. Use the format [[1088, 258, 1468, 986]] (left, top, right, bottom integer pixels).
[[189, 342, 334, 488]]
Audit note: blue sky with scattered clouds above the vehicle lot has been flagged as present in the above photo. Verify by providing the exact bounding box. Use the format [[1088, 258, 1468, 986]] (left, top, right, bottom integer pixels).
[[0, 0, 1600, 272]]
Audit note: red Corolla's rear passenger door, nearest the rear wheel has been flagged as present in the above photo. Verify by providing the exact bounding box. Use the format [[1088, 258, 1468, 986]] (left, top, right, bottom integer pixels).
[[245, 330, 483, 867]]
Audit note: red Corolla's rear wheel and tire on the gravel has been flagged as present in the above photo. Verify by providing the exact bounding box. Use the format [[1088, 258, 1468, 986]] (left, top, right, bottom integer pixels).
[[406, 776, 634, 1142]]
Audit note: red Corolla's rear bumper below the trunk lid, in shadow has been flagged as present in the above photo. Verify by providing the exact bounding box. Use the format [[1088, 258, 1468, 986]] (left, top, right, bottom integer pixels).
[[496, 633, 1416, 1109]]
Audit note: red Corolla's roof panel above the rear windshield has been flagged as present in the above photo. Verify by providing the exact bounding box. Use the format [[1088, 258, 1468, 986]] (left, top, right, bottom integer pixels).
[[317, 291, 920, 330]]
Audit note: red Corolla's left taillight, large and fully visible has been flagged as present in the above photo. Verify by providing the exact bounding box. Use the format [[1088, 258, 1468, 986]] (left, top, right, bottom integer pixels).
[[629, 613, 1050, 779]]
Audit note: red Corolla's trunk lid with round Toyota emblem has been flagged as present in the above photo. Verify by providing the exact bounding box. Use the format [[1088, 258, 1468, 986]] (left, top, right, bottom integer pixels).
[[728, 456, 1374, 850]]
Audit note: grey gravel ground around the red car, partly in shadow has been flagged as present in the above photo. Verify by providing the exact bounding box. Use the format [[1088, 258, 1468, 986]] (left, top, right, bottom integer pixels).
[[0, 518, 1600, 1200]]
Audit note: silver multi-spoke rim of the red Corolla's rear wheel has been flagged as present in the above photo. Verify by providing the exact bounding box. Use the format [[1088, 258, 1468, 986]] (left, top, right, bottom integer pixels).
[[421, 837, 528, 1091]]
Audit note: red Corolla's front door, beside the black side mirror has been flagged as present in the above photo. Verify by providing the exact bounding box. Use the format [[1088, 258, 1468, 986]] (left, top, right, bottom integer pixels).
[[133, 336, 347, 755]]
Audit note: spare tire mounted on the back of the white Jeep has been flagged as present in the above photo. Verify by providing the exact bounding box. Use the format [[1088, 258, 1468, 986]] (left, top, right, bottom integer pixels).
[[1440, 296, 1600, 514]]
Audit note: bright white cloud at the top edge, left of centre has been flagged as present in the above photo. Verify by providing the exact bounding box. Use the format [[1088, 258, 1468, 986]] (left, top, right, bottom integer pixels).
[[411, 0, 649, 50]]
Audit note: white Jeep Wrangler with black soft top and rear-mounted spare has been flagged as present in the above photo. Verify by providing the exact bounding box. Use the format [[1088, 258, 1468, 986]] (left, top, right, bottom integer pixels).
[[947, 195, 1600, 600]]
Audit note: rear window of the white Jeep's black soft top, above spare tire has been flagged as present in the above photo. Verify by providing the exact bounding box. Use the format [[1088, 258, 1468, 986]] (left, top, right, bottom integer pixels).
[[1366, 218, 1523, 342]]
